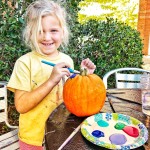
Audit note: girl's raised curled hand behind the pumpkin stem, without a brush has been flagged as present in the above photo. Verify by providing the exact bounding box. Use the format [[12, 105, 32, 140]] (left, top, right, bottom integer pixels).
[[81, 58, 96, 74]]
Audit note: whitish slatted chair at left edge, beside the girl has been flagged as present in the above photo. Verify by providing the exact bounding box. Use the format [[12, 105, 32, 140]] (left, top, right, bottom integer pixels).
[[0, 81, 19, 150]]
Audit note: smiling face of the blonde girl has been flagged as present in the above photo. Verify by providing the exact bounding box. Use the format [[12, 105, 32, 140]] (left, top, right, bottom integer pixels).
[[37, 15, 63, 57]]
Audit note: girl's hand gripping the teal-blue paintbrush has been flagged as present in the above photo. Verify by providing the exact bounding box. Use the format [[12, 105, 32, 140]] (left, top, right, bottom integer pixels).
[[49, 62, 71, 85]]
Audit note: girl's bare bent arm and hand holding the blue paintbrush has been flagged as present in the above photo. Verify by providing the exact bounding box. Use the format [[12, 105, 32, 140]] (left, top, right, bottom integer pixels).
[[15, 63, 70, 113]]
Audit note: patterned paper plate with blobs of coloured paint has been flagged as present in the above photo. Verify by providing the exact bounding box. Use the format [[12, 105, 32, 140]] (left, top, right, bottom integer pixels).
[[81, 113, 148, 150]]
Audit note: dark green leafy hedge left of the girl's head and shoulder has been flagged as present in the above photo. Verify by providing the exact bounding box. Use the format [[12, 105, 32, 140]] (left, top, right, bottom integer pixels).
[[0, 1, 28, 81]]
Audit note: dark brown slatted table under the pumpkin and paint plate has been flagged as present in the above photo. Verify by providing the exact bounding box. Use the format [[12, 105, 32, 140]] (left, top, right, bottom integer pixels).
[[45, 89, 150, 150]]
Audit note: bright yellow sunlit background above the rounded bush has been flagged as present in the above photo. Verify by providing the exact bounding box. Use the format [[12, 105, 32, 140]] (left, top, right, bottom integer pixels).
[[78, 0, 139, 29]]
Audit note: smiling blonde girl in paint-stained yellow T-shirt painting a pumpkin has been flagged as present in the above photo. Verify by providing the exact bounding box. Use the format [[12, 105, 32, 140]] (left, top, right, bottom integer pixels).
[[8, 0, 96, 150]]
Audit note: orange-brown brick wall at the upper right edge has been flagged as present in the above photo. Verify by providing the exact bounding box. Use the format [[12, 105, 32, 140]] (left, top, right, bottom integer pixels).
[[137, 0, 150, 55]]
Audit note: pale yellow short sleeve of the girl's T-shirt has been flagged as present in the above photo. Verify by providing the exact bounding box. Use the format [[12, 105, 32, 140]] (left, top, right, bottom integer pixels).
[[7, 59, 31, 92]]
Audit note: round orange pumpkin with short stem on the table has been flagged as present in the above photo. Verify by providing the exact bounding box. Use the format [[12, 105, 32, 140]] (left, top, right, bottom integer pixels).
[[63, 69, 106, 117]]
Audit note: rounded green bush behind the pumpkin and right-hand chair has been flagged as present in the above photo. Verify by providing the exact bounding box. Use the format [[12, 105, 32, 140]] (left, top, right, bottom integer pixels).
[[68, 18, 143, 77]]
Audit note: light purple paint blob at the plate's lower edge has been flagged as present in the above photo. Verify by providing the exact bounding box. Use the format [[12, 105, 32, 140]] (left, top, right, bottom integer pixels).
[[109, 133, 127, 145]]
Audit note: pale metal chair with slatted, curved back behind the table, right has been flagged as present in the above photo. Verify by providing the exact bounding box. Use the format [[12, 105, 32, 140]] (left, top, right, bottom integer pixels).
[[103, 68, 150, 89]]
